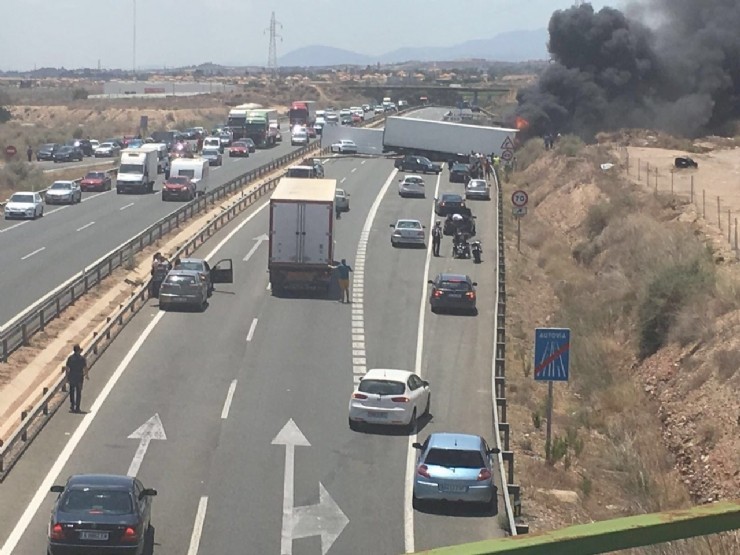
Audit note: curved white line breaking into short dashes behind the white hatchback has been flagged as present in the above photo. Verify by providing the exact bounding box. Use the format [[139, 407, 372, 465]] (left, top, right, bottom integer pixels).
[[352, 169, 398, 385]]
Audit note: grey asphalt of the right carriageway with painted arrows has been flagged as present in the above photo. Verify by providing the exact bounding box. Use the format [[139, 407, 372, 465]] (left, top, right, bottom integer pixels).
[[0, 152, 503, 555]]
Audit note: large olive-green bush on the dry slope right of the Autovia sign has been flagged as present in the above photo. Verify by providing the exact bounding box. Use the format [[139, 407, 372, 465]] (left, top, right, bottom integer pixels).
[[638, 259, 714, 358]]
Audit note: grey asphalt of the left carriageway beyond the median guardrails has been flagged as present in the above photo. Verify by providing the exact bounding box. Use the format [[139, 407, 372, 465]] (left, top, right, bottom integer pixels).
[[0, 133, 299, 323]]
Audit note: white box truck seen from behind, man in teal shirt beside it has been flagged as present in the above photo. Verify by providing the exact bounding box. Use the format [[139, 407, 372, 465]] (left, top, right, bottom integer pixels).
[[268, 177, 337, 295]]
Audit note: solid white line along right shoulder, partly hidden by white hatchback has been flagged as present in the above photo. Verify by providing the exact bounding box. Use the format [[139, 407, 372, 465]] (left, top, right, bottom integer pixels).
[[403, 174, 441, 553]]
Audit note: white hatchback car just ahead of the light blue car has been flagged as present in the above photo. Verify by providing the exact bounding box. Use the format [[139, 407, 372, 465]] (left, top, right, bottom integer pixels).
[[349, 368, 432, 432]]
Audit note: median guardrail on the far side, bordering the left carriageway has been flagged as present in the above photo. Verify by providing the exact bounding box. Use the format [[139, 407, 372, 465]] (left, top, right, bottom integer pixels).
[[0, 143, 316, 362]]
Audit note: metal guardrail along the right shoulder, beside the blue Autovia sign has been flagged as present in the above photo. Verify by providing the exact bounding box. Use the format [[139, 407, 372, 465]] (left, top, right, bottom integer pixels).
[[491, 170, 529, 536]]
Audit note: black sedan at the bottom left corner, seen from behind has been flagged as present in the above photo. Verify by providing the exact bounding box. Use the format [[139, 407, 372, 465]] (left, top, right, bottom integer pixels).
[[47, 474, 157, 555]]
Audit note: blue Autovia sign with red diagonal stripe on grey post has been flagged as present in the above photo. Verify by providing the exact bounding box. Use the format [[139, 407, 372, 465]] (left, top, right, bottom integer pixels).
[[534, 328, 570, 463]]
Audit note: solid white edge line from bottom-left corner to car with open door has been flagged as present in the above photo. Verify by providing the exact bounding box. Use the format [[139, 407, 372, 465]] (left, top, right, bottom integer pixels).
[[0, 312, 165, 555]]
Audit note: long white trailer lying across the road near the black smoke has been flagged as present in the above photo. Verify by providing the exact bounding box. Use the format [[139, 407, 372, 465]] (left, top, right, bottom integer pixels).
[[383, 116, 518, 161]]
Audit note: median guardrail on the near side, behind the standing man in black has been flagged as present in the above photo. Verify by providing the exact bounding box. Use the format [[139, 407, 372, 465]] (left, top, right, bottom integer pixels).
[[0, 146, 323, 482]]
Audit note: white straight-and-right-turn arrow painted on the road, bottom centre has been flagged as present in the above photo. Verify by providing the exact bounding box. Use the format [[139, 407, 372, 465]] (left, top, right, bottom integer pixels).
[[272, 418, 349, 555]]
